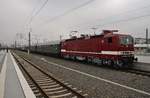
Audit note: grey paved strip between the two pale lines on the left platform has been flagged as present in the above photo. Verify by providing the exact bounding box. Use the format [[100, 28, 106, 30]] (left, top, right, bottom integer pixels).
[[4, 54, 25, 98]]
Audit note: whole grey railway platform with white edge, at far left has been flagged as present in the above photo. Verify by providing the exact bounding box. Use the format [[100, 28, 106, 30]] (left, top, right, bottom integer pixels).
[[0, 52, 36, 98]]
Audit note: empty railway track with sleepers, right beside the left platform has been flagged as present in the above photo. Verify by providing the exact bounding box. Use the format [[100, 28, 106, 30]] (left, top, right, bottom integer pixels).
[[13, 53, 87, 98]]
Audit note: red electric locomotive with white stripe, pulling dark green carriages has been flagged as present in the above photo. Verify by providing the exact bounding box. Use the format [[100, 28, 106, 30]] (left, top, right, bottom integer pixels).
[[61, 30, 134, 68]]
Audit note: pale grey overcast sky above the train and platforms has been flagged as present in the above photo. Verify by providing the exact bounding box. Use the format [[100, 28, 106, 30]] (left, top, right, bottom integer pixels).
[[0, 0, 150, 44]]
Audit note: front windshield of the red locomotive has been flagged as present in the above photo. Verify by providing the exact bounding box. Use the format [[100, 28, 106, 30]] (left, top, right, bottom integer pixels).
[[120, 36, 133, 45]]
